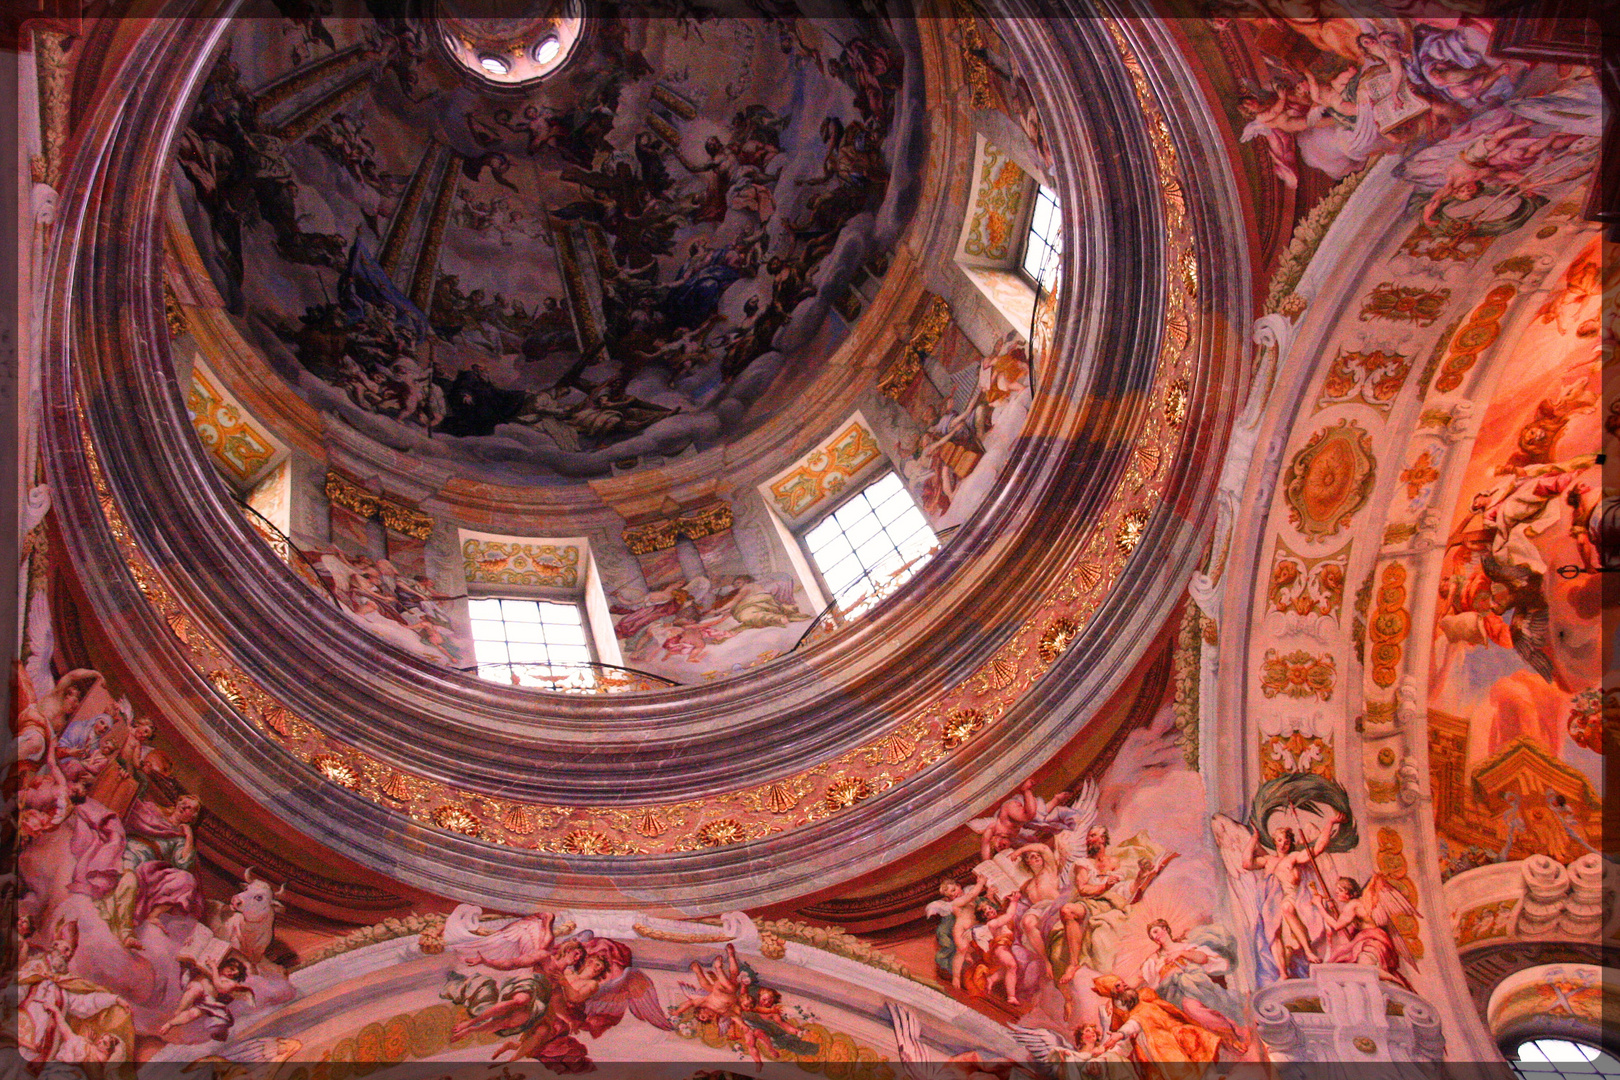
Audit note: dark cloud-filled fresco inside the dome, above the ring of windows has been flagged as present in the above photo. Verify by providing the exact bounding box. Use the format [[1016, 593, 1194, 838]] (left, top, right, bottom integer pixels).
[[173, 5, 923, 483]]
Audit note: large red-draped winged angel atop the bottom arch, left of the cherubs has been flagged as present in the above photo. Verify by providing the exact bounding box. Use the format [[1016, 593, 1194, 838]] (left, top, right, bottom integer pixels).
[[446, 912, 674, 1072]]
